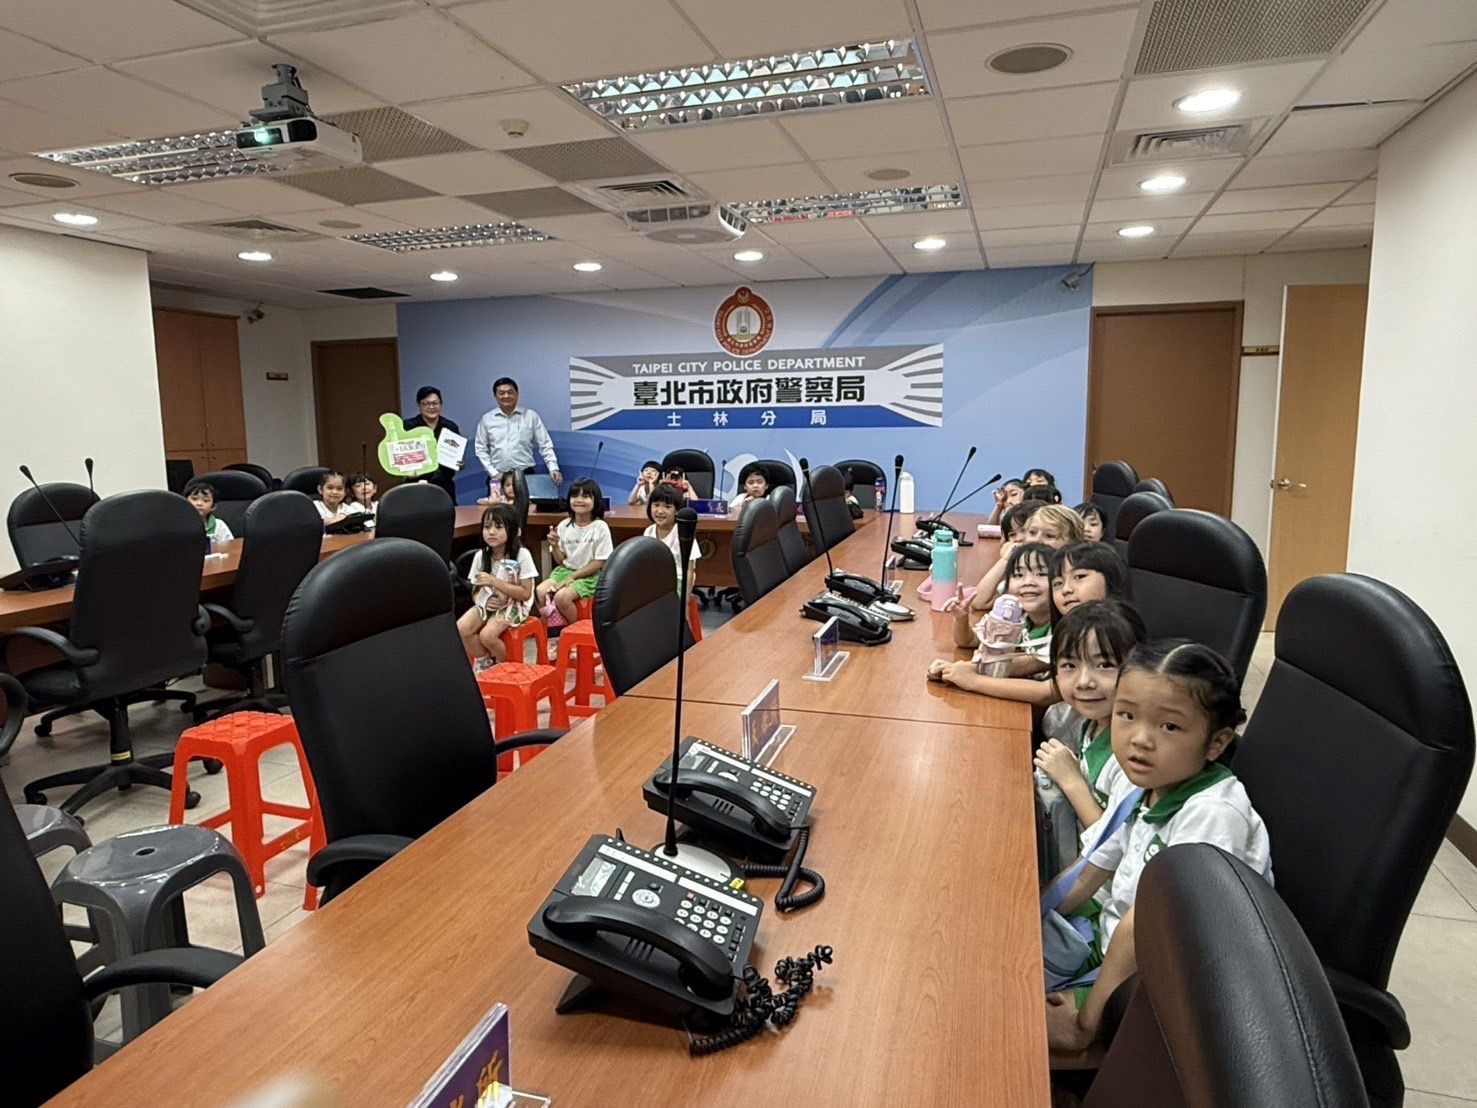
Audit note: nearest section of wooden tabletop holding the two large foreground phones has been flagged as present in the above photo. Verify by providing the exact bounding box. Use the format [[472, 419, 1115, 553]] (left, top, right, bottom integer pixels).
[[55, 697, 1049, 1108]]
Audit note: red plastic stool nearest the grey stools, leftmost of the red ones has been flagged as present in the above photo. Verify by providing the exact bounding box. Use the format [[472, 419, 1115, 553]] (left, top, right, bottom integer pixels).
[[170, 712, 326, 912]]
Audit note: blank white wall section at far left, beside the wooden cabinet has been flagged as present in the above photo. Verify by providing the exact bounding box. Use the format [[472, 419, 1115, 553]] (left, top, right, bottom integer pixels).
[[0, 226, 164, 572]]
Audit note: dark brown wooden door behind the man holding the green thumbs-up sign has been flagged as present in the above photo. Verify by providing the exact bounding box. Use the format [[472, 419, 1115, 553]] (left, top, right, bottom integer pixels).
[[313, 338, 400, 488]]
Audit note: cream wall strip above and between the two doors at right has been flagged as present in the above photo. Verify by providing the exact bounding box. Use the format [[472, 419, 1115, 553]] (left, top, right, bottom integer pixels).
[[1093, 250, 1369, 557]]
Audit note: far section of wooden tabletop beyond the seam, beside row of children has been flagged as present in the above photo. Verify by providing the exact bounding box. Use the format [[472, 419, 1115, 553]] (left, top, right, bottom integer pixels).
[[631, 514, 1031, 731]]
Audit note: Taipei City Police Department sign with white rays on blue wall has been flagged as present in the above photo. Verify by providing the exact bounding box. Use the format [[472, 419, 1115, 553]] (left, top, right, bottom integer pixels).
[[569, 344, 944, 431]]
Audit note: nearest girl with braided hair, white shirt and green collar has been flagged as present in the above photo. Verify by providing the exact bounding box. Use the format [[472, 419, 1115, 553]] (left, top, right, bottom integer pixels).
[[1041, 641, 1272, 1053]]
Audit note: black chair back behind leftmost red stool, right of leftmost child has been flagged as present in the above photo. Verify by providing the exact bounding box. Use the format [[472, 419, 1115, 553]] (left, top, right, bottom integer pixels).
[[230, 490, 323, 660]]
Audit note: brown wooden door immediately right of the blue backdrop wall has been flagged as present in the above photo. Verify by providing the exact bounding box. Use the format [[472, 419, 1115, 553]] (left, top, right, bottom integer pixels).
[[1087, 303, 1241, 516]]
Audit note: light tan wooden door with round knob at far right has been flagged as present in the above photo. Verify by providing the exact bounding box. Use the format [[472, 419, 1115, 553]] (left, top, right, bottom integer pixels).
[[1266, 285, 1369, 628]]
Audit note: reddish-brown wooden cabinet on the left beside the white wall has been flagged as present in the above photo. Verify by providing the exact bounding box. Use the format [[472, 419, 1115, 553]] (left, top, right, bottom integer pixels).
[[154, 307, 247, 473]]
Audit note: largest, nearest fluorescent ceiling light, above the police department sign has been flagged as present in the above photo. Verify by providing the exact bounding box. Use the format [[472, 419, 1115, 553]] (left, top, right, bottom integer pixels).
[[564, 38, 931, 131]]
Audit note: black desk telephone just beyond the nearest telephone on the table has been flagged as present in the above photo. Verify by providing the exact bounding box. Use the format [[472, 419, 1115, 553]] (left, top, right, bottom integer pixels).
[[641, 736, 815, 860]]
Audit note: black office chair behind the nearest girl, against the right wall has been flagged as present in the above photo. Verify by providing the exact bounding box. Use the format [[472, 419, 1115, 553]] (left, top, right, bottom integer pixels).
[[1228, 576, 1474, 1105]]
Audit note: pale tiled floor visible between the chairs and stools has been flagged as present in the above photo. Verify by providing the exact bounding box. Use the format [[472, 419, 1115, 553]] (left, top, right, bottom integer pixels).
[[0, 626, 1477, 1108]]
